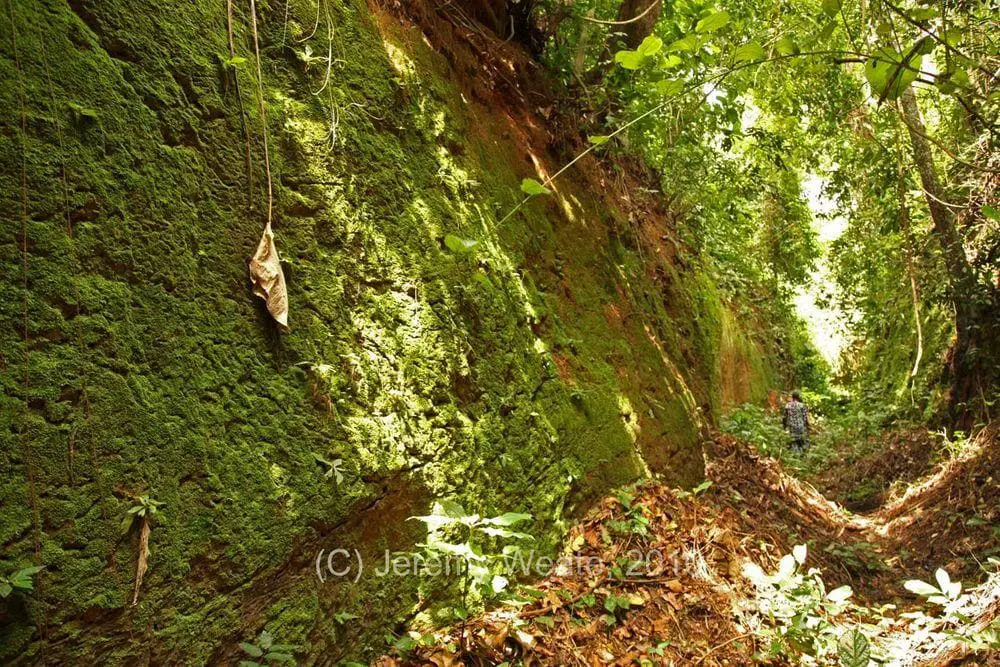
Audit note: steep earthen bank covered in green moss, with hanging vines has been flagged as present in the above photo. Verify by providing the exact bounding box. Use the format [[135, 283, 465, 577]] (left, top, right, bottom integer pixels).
[[0, 0, 772, 664]]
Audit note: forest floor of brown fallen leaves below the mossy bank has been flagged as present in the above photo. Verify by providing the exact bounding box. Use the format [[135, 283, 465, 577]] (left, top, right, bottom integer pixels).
[[382, 431, 1000, 665]]
